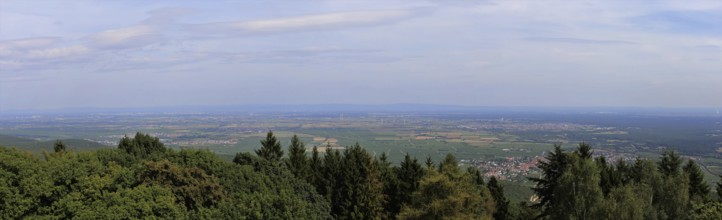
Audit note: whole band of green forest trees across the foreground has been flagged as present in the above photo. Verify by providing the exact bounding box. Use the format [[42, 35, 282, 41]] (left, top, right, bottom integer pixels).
[[0, 132, 722, 219]]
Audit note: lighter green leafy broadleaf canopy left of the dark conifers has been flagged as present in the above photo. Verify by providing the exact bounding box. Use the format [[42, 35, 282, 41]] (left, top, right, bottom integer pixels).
[[0, 132, 331, 219]]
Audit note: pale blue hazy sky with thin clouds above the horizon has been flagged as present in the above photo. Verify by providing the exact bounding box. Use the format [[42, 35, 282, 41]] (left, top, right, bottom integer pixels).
[[0, 0, 722, 111]]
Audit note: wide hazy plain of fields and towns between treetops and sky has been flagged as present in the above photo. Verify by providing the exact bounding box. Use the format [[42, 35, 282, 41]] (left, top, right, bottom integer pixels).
[[0, 109, 722, 184]]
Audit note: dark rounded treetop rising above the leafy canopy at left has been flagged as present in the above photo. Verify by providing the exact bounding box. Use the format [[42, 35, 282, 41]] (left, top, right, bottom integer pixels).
[[118, 132, 165, 158]]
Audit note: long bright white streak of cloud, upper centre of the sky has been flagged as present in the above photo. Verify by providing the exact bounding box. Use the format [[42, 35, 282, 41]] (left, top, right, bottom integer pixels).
[[191, 9, 427, 34]]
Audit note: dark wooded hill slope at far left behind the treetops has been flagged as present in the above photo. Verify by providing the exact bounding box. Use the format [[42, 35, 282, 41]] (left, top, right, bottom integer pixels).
[[0, 134, 109, 154]]
